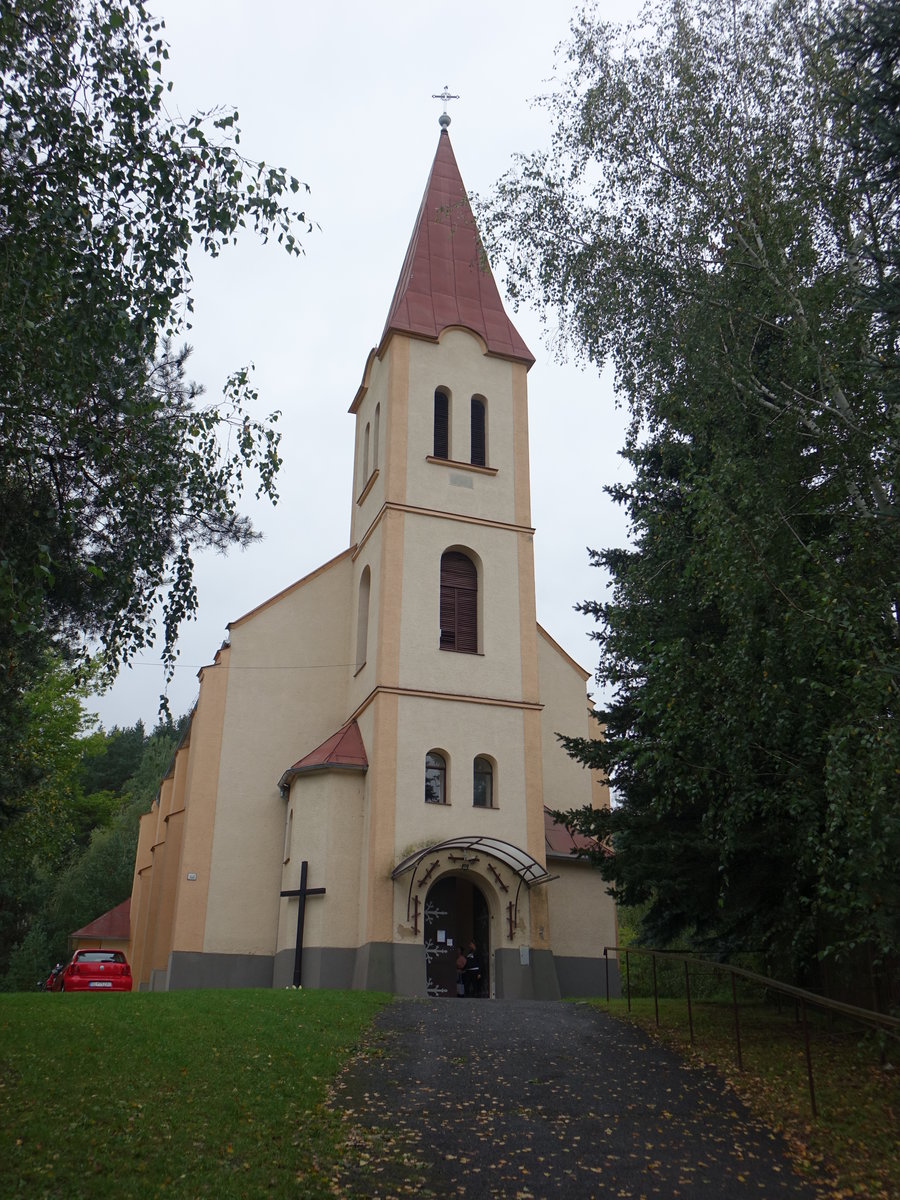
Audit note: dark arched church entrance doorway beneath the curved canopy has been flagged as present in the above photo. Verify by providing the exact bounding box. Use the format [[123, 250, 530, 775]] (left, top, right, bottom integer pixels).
[[424, 875, 491, 996]]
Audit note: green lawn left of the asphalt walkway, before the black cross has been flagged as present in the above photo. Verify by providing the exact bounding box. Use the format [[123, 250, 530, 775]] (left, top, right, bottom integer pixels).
[[0, 990, 389, 1200]]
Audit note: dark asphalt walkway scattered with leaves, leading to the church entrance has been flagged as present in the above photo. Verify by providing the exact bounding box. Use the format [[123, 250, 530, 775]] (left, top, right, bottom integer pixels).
[[334, 1000, 828, 1200]]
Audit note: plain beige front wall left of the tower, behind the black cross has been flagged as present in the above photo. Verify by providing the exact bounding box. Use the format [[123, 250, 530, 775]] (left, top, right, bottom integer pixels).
[[203, 553, 355, 954]]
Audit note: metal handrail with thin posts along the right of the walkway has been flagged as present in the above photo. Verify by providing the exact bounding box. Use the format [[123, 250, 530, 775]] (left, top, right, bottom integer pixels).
[[604, 946, 900, 1117]]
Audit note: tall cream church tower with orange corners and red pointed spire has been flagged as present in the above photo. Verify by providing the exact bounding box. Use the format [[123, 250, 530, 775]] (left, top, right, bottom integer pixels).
[[343, 126, 548, 993]]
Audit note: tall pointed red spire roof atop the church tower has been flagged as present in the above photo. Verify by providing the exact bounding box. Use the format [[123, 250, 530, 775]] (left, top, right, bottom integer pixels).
[[382, 130, 534, 366]]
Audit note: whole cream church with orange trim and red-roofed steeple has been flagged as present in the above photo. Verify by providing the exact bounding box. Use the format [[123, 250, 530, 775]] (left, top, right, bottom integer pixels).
[[128, 118, 616, 997]]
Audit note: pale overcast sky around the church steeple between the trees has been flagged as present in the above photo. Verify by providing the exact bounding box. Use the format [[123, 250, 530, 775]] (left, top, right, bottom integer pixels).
[[89, 0, 637, 728]]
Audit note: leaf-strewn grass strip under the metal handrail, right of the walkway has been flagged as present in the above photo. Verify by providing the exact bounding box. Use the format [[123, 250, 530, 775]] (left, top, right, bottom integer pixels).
[[602, 1000, 900, 1200]]
